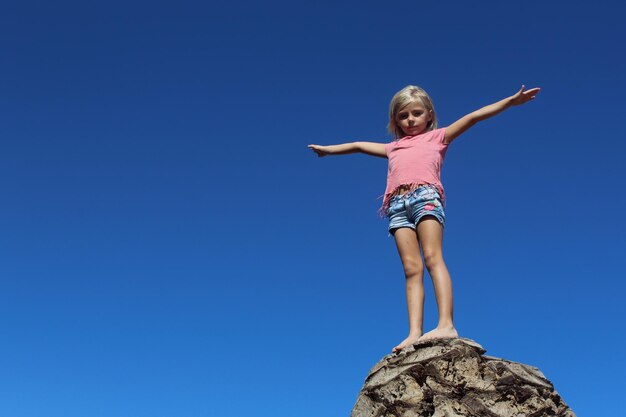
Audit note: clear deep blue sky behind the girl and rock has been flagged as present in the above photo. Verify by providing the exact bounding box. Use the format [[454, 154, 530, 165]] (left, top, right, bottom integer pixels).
[[0, 0, 626, 417]]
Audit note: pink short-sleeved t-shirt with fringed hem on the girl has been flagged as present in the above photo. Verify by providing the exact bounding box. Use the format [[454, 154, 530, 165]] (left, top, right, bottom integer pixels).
[[380, 128, 448, 214]]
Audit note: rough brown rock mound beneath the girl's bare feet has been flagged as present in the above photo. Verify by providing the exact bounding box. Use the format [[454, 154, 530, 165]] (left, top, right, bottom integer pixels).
[[351, 338, 576, 417]]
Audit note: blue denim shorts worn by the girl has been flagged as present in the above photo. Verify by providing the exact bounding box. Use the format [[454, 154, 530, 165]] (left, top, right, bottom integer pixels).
[[387, 185, 446, 234]]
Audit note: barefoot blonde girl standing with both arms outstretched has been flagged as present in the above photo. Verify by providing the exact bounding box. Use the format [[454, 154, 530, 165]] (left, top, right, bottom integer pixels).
[[309, 85, 540, 352]]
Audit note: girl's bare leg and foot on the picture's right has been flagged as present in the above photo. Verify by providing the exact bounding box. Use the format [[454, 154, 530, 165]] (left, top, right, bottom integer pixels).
[[417, 216, 459, 340]]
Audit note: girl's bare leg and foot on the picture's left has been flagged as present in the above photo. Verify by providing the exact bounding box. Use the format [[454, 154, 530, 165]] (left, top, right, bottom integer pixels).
[[393, 227, 424, 352]]
